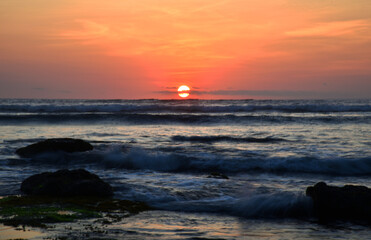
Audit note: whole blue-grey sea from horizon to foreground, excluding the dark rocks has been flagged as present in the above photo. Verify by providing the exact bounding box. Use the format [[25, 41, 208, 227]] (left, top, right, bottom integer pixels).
[[0, 99, 371, 239]]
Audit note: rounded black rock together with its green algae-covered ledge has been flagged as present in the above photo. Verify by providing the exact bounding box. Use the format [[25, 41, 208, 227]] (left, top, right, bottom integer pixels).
[[0, 169, 153, 228]]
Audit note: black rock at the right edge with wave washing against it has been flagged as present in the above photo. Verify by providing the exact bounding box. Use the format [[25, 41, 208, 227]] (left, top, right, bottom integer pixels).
[[306, 182, 371, 222]]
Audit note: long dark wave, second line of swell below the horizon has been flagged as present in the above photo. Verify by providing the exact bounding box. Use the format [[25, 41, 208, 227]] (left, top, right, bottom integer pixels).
[[0, 113, 371, 124]]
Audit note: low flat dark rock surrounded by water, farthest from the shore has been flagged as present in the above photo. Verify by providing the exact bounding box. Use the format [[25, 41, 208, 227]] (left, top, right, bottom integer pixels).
[[16, 138, 93, 157]]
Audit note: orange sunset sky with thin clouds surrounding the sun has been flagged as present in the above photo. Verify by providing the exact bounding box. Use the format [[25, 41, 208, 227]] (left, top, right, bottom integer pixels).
[[0, 0, 371, 99]]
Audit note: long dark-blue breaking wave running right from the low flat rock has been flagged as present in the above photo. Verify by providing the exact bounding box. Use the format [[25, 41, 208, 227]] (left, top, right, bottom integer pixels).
[[13, 147, 371, 176]]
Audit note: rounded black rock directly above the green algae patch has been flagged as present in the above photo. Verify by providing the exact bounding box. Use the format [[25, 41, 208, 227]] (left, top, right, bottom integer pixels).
[[21, 169, 113, 197]]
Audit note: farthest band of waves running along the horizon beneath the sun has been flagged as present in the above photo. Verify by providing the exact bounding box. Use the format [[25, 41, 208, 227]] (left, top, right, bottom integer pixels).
[[0, 100, 371, 113]]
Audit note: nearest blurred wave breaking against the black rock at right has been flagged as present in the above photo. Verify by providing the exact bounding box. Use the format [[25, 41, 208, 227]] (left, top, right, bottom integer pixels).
[[118, 183, 313, 219]]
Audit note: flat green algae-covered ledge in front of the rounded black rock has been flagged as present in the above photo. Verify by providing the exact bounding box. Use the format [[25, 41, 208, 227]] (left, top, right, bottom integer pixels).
[[0, 196, 151, 228]]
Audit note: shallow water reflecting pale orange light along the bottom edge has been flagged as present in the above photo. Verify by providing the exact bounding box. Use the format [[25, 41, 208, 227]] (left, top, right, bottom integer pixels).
[[8, 211, 370, 240]]
